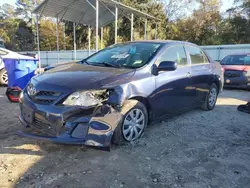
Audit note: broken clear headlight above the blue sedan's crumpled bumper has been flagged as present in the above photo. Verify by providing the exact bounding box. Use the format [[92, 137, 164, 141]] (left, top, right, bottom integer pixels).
[[63, 90, 107, 107]]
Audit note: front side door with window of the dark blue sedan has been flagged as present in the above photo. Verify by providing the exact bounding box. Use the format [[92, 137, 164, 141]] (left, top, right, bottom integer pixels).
[[153, 45, 195, 117]]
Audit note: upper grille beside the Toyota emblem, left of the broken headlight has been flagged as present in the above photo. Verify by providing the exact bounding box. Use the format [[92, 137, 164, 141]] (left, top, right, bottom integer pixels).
[[30, 91, 62, 105]]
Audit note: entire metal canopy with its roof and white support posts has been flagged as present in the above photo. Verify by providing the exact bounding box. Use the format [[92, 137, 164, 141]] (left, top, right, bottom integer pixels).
[[33, 0, 159, 67]]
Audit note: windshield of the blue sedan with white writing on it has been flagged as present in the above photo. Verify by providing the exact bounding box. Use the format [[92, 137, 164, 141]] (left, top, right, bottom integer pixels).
[[85, 42, 161, 68]]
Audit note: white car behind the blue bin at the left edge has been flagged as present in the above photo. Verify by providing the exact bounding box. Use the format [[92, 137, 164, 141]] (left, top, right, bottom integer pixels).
[[0, 47, 34, 85]]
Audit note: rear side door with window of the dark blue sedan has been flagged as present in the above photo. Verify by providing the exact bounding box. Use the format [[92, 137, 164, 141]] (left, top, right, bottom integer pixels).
[[185, 45, 213, 103]]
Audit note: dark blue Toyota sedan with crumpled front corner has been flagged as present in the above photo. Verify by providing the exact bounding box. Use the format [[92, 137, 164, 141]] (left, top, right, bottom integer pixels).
[[18, 41, 224, 149]]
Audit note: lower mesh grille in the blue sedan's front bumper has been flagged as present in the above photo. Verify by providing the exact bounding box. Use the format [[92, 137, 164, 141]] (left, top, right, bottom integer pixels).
[[31, 117, 56, 137]]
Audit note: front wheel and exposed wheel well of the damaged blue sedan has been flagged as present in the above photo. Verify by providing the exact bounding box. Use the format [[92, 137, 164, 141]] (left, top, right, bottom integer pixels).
[[112, 100, 148, 145]]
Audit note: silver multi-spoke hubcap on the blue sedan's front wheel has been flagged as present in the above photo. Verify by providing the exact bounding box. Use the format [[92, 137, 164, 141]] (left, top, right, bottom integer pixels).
[[122, 109, 145, 141]]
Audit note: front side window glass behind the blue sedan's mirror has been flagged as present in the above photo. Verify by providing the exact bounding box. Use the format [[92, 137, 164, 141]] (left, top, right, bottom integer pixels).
[[156, 46, 188, 67]]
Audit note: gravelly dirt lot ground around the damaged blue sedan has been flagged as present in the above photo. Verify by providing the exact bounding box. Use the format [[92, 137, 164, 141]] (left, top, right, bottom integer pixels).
[[0, 88, 250, 188]]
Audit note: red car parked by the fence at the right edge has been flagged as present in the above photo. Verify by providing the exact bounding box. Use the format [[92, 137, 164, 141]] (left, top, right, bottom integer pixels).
[[221, 53, 250, 89]]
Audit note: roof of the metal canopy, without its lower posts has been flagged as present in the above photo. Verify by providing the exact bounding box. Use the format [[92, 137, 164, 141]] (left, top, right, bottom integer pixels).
[[33, 0, 158, 27]]
